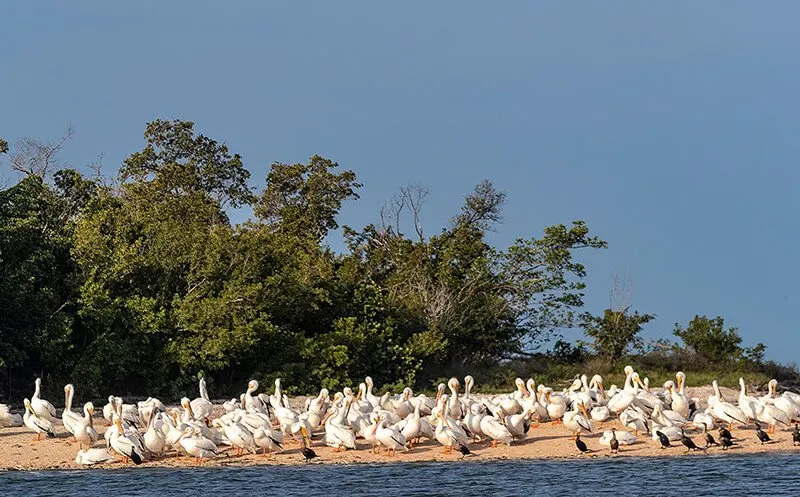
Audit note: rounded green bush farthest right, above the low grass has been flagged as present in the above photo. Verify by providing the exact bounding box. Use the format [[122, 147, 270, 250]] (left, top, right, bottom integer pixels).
[[674, 315, 752, 364]]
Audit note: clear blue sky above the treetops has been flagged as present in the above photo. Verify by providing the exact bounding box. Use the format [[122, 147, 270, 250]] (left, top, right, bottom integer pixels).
[[0, 1, 800, 361]]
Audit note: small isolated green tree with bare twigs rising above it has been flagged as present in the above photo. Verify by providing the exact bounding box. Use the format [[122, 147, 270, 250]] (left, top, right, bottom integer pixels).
[[581, 308, 655, 361]]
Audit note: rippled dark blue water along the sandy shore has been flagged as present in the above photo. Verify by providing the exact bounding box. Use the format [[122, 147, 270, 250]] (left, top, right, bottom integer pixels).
[[0, 454, 800, 497]]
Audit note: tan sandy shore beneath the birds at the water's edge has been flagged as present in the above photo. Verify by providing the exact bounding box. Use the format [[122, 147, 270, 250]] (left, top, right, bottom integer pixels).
[[0, 389, 800, 470]]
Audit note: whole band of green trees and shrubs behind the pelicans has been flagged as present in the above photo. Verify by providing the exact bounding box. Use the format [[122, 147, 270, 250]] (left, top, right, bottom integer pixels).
[[0, 120, 798, 400]]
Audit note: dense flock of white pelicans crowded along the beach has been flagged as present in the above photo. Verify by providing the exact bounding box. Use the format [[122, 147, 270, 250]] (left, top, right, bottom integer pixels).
[[0, 366, 800, 465]]
